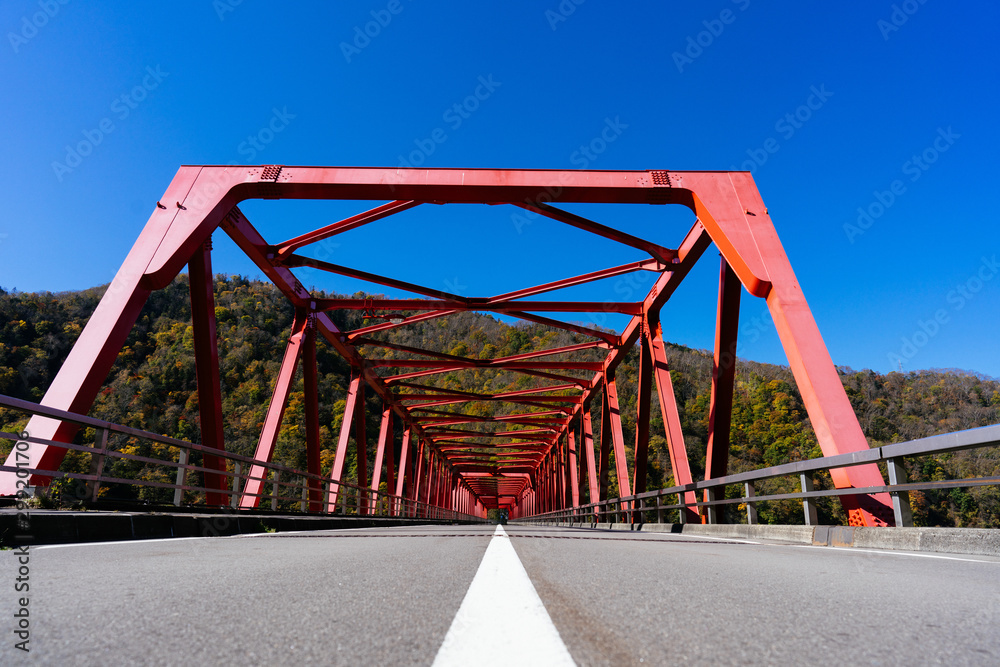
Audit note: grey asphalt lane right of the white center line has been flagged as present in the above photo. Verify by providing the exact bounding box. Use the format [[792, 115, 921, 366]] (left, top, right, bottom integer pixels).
[[507, 526, 1000, 665]]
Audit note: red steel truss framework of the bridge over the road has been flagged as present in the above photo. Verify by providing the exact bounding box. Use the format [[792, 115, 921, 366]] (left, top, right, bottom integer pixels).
[[0, 165, 898, 526]]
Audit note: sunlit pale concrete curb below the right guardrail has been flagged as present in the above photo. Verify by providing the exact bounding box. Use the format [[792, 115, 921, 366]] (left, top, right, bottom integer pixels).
[[517, 521, 1000, 556]]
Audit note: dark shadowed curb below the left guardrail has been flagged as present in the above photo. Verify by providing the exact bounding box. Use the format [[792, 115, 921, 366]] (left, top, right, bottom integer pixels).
[[0, 510, 480, 547]]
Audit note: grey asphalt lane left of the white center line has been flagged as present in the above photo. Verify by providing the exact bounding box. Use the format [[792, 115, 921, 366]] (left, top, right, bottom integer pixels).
[[0, 526, 494, 667]]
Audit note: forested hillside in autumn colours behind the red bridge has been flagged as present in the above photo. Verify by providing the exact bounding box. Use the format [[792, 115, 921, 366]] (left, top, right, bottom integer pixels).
[[0, 276, 1000, 527]]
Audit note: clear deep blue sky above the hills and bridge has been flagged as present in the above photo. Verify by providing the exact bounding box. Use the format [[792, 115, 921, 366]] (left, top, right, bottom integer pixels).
[[0, 0, 1000, 377]]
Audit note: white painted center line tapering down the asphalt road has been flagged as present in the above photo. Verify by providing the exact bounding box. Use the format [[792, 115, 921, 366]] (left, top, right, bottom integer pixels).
[[434, 526, 576, 667]]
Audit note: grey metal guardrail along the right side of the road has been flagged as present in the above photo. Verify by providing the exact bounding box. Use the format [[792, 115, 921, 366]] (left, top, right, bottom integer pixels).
[[515, 424, 1000, 526]]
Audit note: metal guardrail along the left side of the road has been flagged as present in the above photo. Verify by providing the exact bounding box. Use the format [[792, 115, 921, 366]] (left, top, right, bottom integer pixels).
[[0, 394, 483, 521]]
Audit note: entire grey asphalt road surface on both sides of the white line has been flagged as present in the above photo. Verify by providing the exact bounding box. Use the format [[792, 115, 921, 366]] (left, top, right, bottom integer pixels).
[[0, 526, 1000, 667]]
